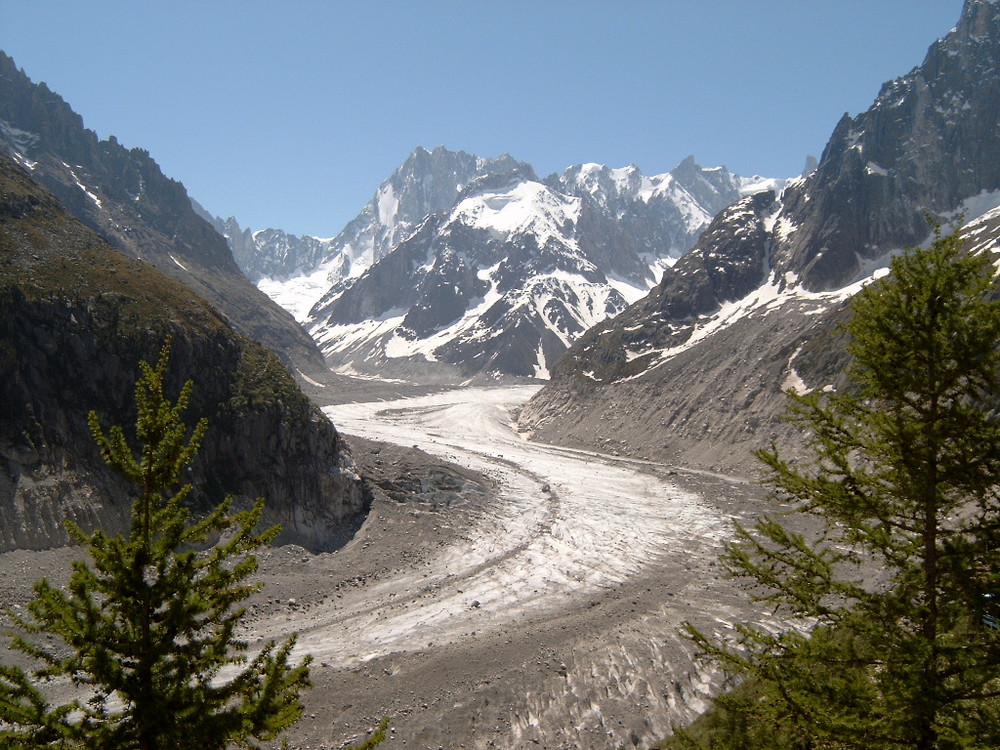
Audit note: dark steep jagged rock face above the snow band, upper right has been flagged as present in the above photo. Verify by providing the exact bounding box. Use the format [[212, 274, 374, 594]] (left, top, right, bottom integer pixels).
[[774, 0, 1000, 291]]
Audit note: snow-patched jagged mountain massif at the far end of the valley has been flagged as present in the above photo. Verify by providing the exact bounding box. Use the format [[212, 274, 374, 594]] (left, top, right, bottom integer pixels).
[[227, 147, 780, 380]]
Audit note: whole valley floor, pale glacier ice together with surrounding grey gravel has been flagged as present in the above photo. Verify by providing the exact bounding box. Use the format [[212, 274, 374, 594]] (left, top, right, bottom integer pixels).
[[0, 386, 772, 750]]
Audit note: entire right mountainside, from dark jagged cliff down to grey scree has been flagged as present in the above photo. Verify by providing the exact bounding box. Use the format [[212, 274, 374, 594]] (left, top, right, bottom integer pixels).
[[521, 0, 1000, 478]]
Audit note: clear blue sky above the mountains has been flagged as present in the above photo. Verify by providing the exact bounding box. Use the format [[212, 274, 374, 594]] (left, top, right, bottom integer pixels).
[[0, 0, 962, 236]]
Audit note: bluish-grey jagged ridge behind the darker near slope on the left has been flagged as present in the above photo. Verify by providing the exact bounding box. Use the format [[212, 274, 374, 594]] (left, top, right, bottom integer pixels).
[[0, 52, 323, 372]]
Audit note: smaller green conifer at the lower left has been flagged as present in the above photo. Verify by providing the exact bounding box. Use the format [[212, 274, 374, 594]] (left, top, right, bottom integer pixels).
[[0, 344, 310, 750]]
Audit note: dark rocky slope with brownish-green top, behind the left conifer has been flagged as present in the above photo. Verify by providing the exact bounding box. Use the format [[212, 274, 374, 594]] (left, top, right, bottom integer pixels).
[[0, 154, 367, 550]]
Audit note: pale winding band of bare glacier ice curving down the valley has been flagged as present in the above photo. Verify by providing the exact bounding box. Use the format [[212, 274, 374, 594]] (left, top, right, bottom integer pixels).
[[282, 386, 729, 659]]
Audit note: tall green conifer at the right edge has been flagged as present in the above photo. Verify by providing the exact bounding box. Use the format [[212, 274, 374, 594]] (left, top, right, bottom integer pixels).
[[686, 232, 1000, 750]]
